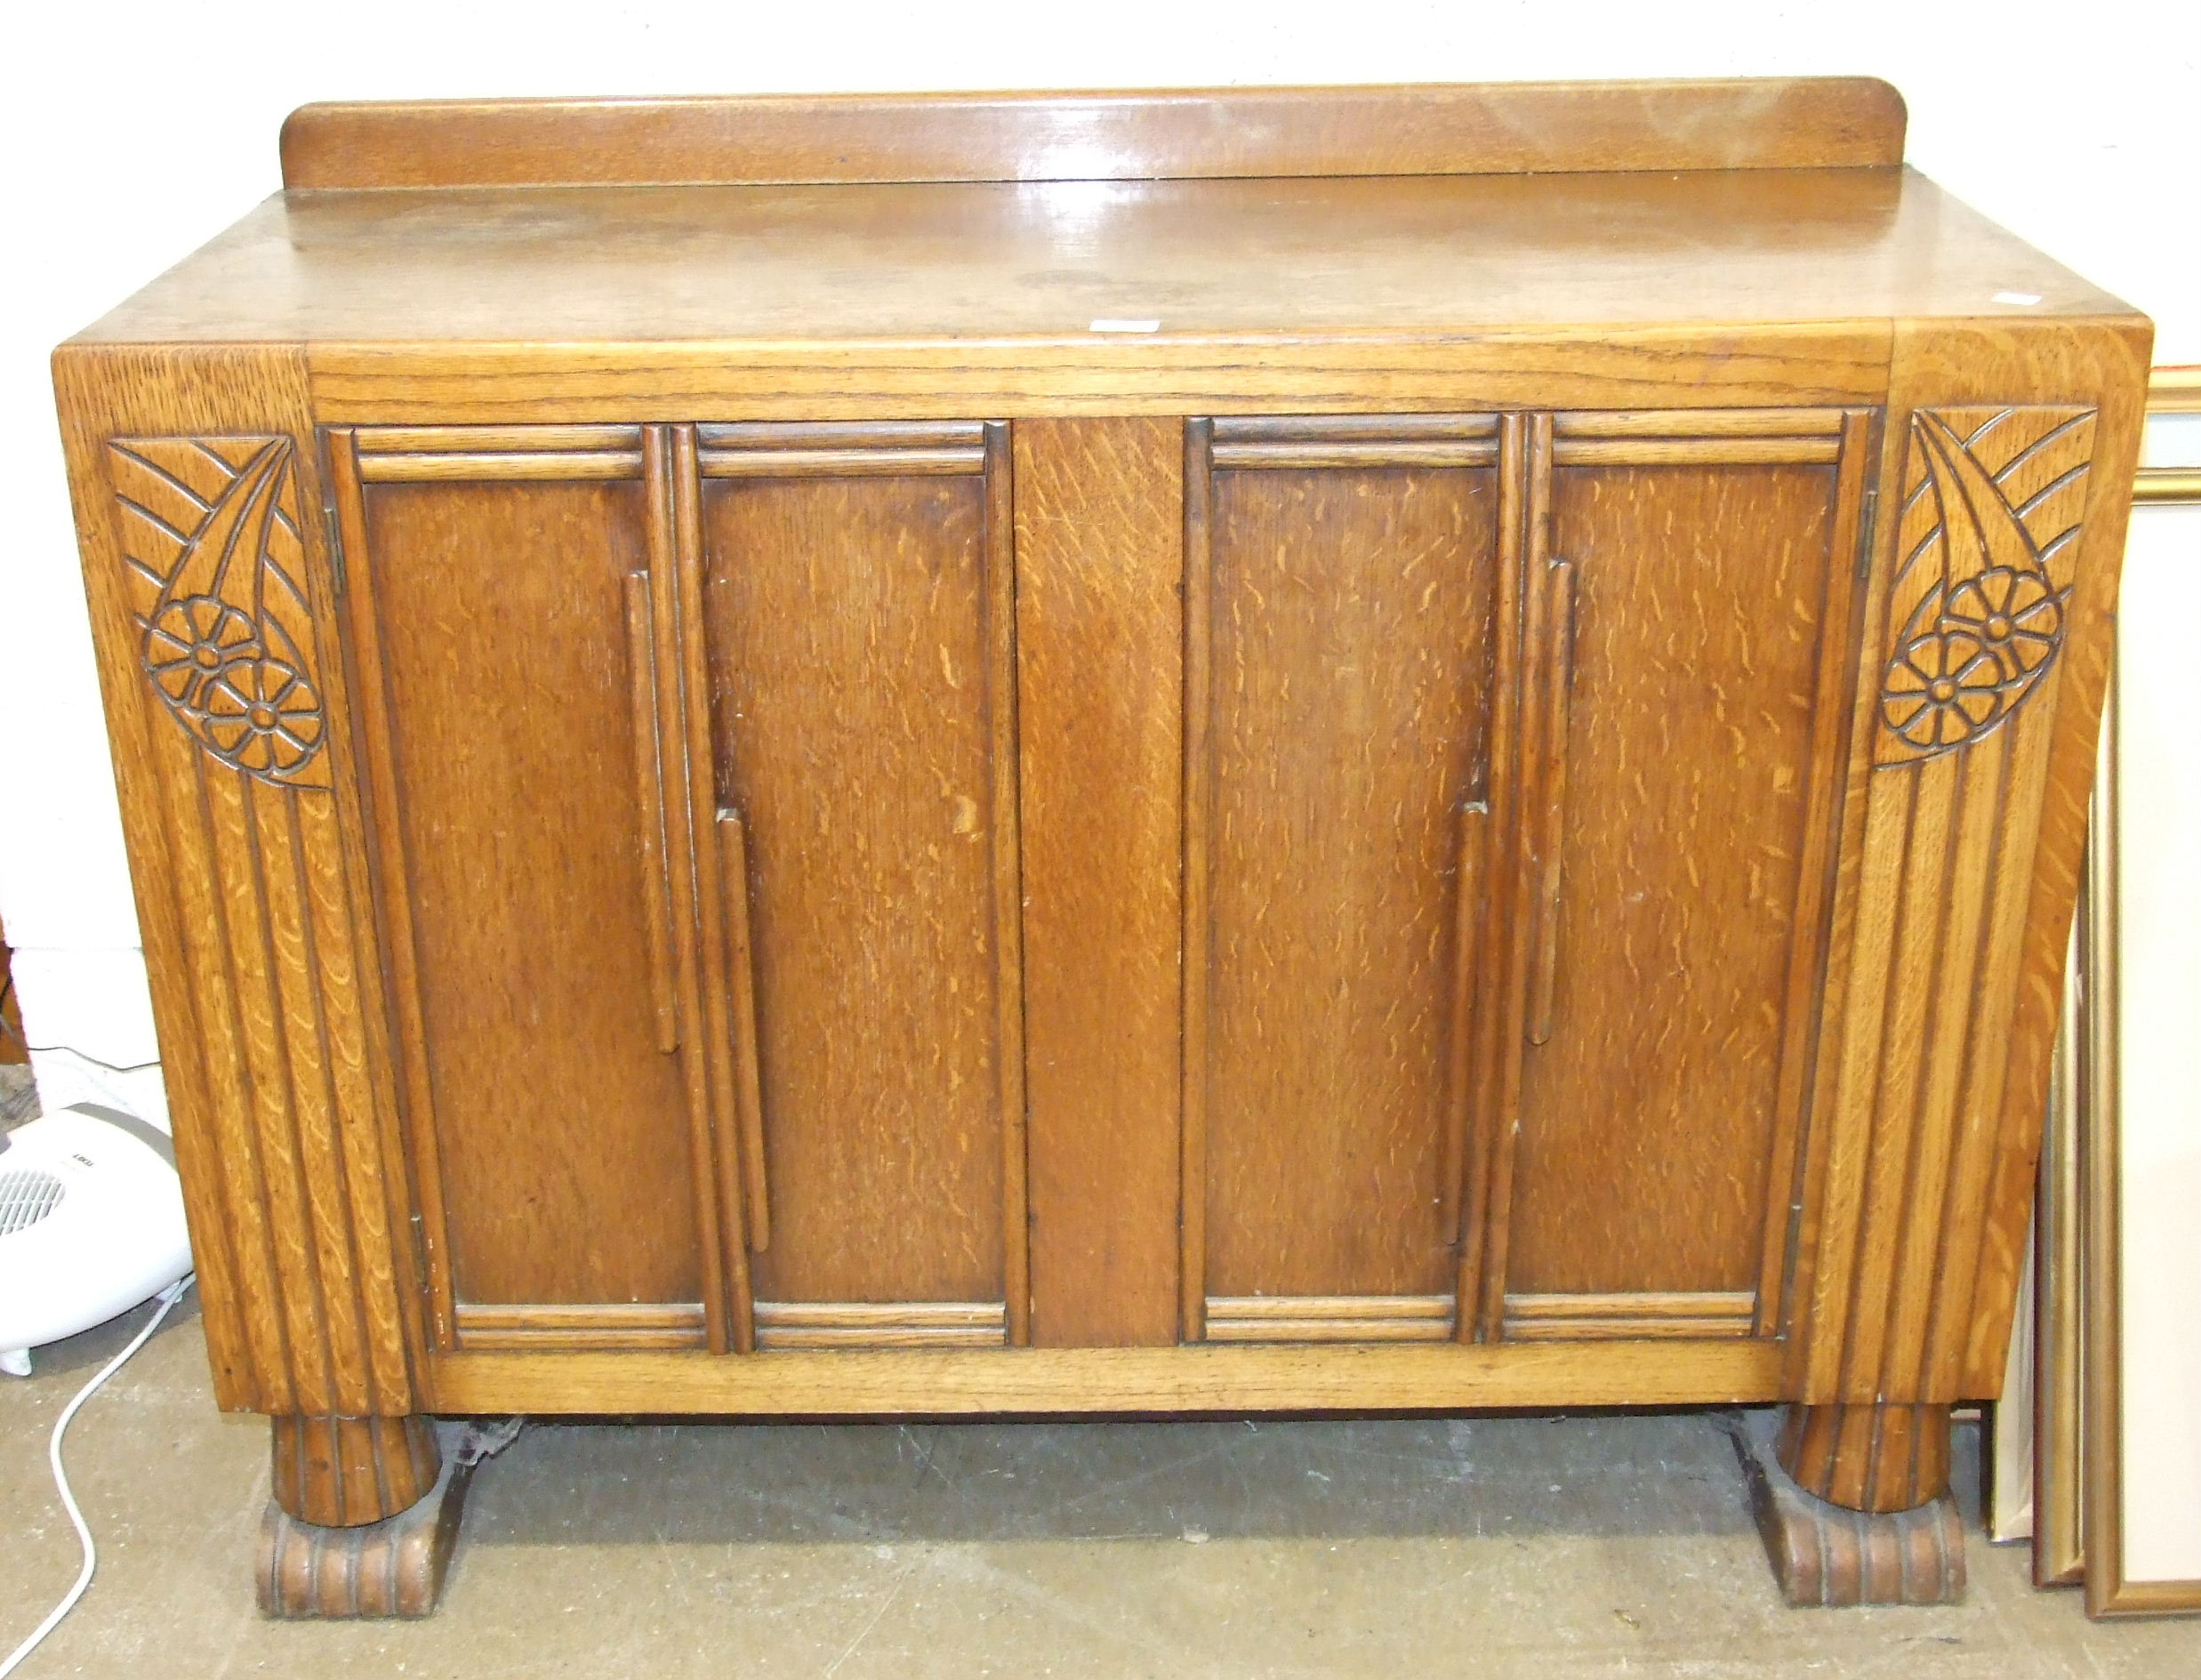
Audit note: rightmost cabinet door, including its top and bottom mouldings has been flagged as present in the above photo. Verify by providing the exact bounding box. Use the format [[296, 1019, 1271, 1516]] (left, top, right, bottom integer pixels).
[[1479, 409, 1868, 1337]]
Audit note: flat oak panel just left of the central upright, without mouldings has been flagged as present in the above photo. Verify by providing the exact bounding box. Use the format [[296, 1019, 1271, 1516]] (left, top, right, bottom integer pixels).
[[703, 473, 1021, 1301]]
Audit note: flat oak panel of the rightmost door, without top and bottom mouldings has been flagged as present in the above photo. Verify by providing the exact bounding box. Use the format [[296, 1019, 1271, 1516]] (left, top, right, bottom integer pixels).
[[1506, 460, 1853, 1295]]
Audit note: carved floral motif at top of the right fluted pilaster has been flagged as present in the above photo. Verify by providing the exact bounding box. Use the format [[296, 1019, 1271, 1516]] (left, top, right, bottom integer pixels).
[[1877, 407, 2093, 767]]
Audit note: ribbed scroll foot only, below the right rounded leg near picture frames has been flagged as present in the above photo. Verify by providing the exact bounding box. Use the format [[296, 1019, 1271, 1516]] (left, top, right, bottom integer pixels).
[[1734, 1429, 1964, 1607]]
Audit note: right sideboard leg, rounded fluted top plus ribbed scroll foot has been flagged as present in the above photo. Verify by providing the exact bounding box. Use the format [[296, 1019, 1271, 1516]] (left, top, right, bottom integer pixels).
[[1737, 1405, 1964, 1605]]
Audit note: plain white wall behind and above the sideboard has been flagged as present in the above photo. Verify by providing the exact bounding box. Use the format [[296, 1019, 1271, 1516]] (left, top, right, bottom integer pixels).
[[0, 0, 2201, 1122]]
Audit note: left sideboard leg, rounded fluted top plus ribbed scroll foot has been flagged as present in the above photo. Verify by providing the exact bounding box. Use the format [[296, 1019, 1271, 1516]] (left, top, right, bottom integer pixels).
[[258, 1416, 473, 1619]]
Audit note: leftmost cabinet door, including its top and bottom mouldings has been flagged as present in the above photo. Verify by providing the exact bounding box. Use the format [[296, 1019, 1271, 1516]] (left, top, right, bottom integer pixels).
[[330, 427, 737, 1350]]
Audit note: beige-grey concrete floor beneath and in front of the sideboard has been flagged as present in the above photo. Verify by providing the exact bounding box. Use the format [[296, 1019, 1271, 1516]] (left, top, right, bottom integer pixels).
[[0, 1308, 2201, 1680]]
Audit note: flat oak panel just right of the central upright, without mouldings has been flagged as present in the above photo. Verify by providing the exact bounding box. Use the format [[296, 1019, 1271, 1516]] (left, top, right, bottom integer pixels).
[[1186, 455, 1497, 1297]]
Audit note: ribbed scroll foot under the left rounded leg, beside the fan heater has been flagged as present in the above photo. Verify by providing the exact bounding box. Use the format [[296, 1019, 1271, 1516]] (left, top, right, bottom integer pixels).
[[258, 1455, 473, 1620]]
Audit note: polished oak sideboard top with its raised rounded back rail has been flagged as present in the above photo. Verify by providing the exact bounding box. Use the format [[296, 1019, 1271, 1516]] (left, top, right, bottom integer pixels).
[[64, 79, 2133, 409]]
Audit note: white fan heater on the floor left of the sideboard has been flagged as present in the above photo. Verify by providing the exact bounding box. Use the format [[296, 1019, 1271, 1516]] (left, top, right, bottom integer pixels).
[[0, 1103, 191, 1376]]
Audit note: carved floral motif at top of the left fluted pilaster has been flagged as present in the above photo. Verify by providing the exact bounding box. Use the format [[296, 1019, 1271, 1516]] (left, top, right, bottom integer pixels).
[[108, 438, 328, 788]]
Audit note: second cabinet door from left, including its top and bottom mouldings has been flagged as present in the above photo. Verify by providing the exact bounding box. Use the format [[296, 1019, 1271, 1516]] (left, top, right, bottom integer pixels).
[[695, 422, 1028, 1347]]
